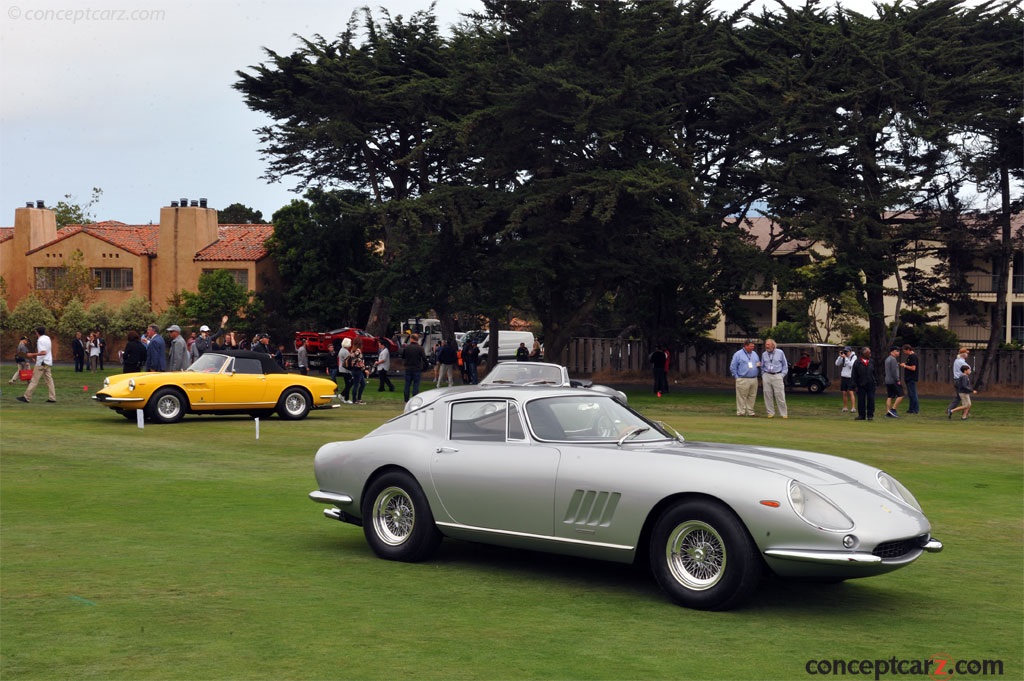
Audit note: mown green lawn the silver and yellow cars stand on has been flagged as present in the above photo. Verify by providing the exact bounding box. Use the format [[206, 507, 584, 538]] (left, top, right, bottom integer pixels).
[[0, 366, 1024, 681]]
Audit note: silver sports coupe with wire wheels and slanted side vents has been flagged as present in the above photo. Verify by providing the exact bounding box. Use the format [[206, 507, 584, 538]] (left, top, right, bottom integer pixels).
[[309, 386, 942, 609]]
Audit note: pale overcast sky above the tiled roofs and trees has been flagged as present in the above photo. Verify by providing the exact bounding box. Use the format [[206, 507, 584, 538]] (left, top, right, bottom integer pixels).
[[0, 0, 937, 226]]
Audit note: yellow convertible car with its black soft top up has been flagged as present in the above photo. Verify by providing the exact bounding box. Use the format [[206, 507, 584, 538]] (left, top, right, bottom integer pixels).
[[92, 350, 338, 423]]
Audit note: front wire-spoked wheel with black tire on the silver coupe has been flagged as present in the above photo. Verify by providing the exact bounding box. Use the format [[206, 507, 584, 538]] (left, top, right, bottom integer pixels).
[[650, 500, 763, 610]]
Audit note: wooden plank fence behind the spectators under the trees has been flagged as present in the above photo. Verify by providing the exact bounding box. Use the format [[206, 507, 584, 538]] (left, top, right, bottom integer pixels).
[[562, 338, 1024, 384]]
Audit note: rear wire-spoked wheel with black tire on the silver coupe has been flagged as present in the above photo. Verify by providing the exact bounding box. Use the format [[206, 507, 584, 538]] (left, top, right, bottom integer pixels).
[[362, 471, 441, 563]]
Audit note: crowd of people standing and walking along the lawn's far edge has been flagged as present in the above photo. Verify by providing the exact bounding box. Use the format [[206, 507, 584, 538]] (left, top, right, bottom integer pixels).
[[8, 315, 977, 421]]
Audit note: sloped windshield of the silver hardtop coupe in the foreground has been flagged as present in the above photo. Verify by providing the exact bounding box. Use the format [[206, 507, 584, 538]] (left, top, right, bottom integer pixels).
[[525, 394, 673, 444]]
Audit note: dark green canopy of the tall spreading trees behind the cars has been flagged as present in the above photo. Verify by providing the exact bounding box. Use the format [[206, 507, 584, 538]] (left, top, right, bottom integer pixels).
[[234, 0, 1022, 356]]
